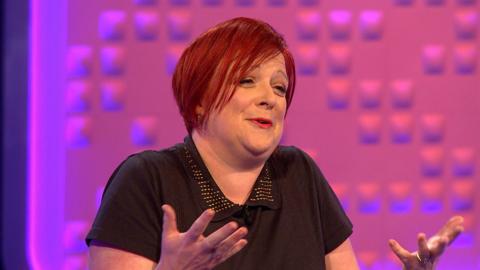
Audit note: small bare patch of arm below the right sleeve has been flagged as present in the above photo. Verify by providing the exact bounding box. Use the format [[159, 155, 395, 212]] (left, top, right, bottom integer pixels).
[[325, 239, 359, 270]]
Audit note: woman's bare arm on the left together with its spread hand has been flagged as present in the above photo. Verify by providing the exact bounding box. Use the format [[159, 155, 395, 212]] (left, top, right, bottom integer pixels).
[[88, 205, 248, 270]]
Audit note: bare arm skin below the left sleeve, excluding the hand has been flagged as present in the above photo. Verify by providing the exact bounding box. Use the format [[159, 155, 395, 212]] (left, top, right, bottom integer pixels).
[[88, 242, 157, 270]]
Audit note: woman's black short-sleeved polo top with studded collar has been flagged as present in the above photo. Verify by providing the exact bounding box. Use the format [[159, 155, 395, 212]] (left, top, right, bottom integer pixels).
[[86, 137, 352, 270]]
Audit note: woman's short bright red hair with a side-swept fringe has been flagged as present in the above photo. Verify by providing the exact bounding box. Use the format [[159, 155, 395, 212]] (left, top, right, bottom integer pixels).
[[172, 17, 295, 133]]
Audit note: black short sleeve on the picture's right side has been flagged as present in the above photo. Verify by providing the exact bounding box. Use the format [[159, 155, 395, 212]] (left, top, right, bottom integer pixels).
[[304, 153, 353, 254]]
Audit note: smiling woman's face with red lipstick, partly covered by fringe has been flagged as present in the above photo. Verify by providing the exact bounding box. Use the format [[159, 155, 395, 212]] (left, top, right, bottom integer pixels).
[[200, 54, 288, 162]]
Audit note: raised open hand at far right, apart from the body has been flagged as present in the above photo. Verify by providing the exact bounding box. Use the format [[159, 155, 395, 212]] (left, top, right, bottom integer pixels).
[[388, 216, 463, 270]]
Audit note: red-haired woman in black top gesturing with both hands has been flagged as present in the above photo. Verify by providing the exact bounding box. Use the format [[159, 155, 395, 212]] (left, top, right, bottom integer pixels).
[[87, 18, 462, 269]]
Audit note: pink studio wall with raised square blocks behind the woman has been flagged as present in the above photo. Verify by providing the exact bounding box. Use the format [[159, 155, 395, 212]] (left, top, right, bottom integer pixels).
[[49, 0, 480, 269]]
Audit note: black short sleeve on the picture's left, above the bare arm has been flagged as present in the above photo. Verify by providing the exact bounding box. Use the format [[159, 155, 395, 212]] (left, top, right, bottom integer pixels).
[[86, 155, 162, 262]]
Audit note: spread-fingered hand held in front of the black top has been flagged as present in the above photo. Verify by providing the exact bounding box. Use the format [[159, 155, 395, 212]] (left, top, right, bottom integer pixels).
[[156, 204, 247, 270]]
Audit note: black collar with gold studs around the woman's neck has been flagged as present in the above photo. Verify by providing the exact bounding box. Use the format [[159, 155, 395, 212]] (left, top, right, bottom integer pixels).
[[177, 136, 281, 221]]
